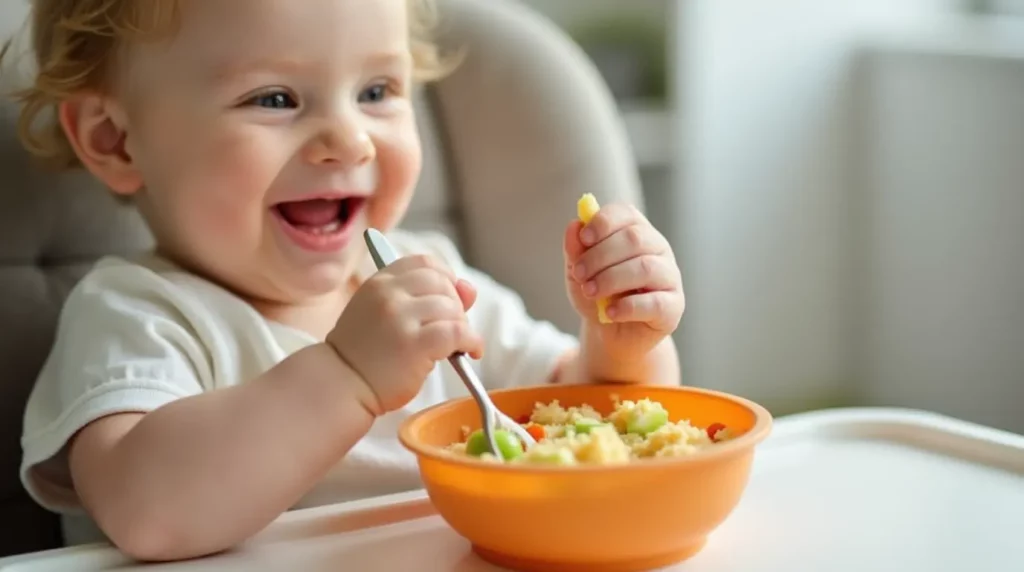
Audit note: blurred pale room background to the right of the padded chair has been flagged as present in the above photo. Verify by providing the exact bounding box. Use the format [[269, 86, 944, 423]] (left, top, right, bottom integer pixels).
[[522, 0, 1024, 433]]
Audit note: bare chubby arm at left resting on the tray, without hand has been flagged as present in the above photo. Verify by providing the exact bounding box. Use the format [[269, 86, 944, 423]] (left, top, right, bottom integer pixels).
[[70, 344, 374, 561]]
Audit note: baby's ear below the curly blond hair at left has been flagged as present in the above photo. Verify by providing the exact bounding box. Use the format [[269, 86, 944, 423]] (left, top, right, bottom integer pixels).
[[57, 94, 142, 195]]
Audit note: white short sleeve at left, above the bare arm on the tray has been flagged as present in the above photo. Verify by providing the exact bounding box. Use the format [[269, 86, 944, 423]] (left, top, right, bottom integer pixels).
[[22, 263, 209, 512]]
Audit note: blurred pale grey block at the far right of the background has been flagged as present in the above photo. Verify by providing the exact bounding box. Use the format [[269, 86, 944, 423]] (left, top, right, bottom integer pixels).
[[856, 21, 1024, 433]]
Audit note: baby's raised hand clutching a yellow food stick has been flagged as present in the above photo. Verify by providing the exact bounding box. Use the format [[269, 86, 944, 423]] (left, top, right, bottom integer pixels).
[[563, 204, 685, 357]]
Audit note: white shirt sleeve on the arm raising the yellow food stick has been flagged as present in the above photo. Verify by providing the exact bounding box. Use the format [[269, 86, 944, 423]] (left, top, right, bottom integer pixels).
[[395, 233, 579, 390]]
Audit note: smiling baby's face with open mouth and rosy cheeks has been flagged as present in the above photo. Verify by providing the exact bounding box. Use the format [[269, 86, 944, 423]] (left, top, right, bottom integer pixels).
[[121, 0, 421, 304]]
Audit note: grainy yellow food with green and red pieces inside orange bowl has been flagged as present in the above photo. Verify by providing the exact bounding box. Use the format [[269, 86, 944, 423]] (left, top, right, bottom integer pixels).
[[446, 395, 730, 466]]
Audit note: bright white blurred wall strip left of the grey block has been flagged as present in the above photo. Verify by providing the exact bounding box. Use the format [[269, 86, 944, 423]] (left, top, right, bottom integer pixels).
[[673, 0, 946, 412]]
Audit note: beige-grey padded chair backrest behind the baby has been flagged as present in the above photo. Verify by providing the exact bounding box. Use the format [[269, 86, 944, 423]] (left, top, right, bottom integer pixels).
[[0, 0, 640, 555]]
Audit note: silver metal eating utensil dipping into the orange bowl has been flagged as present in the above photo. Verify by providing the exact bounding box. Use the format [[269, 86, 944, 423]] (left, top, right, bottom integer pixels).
[[362, 228, 537, 459]]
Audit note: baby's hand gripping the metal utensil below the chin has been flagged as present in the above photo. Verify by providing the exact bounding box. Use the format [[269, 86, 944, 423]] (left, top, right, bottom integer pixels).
[[327, 256, 483, 415]]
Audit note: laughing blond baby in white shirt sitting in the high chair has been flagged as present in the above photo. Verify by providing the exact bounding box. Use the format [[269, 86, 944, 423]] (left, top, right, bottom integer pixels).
[[6, 0, 684, 560]]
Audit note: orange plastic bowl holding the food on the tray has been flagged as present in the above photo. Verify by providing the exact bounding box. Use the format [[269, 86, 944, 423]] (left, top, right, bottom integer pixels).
[[398, 384, 772, 572]]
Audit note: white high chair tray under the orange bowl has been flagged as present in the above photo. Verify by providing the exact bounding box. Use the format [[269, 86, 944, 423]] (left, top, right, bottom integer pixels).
[[0, 409, 1024, 572]]
